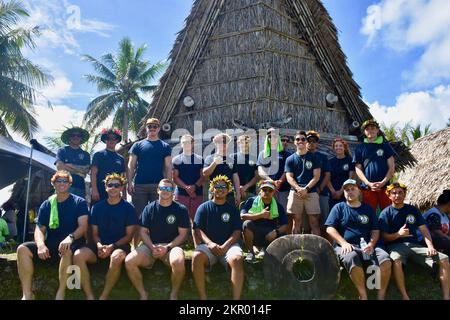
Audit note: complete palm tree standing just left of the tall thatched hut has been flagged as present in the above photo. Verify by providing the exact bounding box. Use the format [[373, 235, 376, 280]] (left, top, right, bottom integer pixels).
[[83, 38, 166, 142]]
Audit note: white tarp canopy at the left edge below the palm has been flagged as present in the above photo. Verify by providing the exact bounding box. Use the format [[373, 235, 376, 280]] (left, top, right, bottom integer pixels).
[[0, 136, 56, 189]]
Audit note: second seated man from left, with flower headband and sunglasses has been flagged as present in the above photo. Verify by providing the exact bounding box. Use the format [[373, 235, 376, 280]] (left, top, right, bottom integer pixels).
[[73, 173, 138, 300]]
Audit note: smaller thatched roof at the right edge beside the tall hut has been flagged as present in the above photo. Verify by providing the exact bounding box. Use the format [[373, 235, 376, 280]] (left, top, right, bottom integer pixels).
[[399, 128, 450, 210]]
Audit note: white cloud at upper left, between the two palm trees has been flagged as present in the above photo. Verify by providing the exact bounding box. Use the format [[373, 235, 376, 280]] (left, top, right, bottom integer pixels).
[[20, 0, 114, 54]]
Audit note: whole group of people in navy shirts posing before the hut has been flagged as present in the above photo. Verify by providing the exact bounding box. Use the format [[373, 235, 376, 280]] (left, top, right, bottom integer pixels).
[[17, 118, 450, 299]]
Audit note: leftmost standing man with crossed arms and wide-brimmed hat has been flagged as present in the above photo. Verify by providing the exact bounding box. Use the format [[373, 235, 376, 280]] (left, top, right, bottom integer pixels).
[[56, 127, 91, 198]]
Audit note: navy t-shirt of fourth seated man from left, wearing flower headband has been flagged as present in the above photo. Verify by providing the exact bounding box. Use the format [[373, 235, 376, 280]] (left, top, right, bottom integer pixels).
[[194, 200, 242, 245]]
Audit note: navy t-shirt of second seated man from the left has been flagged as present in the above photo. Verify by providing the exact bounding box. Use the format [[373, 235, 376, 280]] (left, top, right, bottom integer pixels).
[[89, 199, 138, 245]]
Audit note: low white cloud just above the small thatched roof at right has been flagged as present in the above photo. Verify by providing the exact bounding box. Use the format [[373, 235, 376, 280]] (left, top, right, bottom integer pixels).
[[369, 85, 450, 130]]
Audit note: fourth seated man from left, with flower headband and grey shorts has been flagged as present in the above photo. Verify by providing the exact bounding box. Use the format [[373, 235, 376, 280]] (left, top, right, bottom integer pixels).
[[192, 175, 244, 300]]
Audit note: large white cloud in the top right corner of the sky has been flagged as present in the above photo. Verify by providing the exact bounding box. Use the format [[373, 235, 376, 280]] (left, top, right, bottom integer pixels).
[[361, 0, 450, 87]]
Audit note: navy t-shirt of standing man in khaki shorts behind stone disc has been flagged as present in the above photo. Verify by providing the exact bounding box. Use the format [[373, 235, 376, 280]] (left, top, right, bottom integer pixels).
[[284, 151, 320, 192]]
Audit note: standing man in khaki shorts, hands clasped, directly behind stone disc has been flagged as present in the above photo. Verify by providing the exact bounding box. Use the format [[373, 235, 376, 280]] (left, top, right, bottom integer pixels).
[[285, 131, 320, 236]]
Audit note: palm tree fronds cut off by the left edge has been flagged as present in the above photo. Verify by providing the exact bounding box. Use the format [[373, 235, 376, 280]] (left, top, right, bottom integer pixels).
[[0, 0, 51, 139]]
